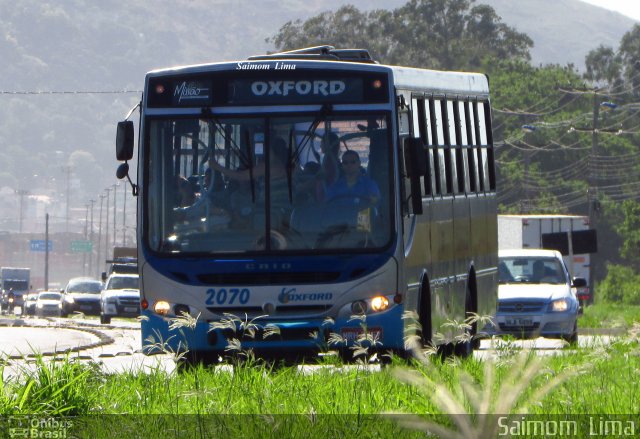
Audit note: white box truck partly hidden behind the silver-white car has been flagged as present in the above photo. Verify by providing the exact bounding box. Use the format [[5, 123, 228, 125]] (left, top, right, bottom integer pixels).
[[498, 215, 597, 303]]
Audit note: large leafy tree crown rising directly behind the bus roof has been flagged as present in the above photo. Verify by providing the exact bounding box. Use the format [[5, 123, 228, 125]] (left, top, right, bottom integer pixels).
[[267, 0, 533, 70]]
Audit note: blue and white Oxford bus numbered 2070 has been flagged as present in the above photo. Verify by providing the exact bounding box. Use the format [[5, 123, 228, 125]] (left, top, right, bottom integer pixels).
[[116, 46, 497, 357]]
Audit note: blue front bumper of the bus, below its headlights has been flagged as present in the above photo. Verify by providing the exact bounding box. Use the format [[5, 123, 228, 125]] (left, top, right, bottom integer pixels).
[[141, 305, 404, 354]]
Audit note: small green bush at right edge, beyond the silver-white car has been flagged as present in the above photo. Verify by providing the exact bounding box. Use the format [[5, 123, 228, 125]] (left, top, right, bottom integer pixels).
[[596, 265, 640, 305]]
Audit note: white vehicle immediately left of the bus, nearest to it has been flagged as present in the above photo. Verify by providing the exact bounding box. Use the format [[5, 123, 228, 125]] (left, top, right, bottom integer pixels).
[[100, 273, 140, 324]]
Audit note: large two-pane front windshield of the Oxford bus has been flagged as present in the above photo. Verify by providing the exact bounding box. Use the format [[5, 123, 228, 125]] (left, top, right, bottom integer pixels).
[[144, 113, 393, 254]]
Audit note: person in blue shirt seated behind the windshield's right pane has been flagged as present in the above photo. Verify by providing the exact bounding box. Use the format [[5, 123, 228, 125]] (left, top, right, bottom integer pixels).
[[325, 150, 380, 206]]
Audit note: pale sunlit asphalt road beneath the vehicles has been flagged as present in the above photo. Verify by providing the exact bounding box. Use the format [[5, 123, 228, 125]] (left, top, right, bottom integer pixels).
[[0, 318, 614, 377]]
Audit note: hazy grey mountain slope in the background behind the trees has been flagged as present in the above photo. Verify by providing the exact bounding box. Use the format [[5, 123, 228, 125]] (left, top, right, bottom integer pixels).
[[0, 0, 636, 234]]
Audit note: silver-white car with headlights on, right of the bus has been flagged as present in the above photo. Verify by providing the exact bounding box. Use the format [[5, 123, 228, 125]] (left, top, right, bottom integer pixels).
[[487, 249, 587, 344]]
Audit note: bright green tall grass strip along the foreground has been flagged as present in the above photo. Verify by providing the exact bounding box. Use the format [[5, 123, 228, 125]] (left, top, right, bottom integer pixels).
[[0, 318, 640, 438]]
